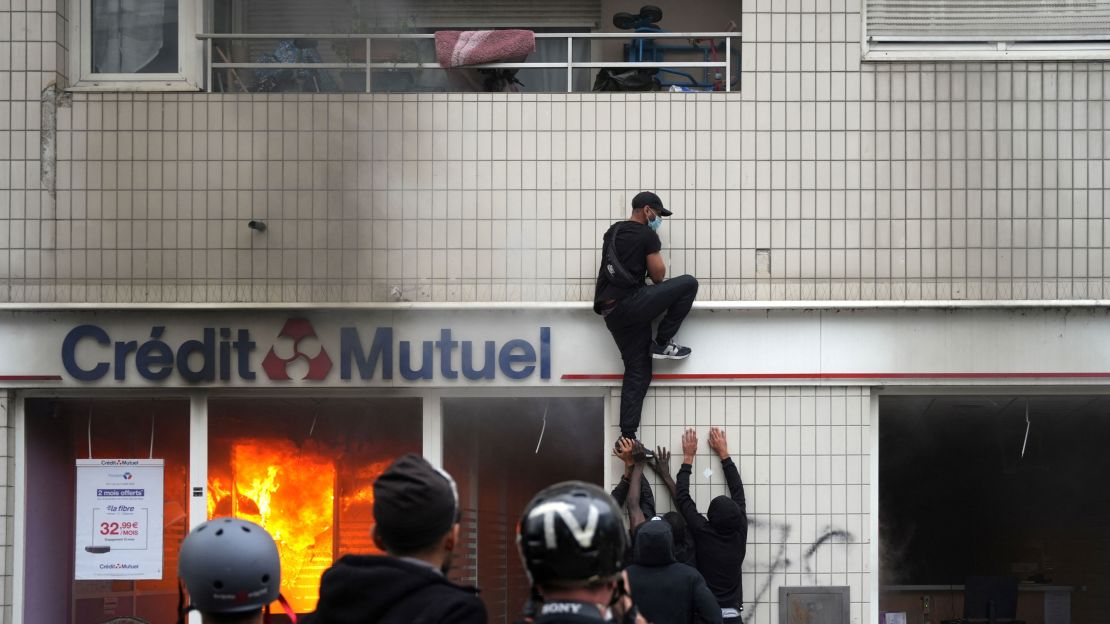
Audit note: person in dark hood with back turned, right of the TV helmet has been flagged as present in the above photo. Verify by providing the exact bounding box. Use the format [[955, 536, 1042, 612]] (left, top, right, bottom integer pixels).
[[628, 517, 722, 624]]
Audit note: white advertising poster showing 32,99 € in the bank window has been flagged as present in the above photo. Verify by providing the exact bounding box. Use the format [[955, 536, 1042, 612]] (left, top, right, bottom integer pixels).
[[73, 460, 163, 581]]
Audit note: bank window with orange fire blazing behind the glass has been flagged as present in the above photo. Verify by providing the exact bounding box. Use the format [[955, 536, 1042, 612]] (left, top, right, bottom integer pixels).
[[206, 397, 422, 622]]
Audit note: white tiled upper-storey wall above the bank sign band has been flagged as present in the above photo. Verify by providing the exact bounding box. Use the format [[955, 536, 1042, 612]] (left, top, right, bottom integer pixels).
[[0, 0, 1110, 302]]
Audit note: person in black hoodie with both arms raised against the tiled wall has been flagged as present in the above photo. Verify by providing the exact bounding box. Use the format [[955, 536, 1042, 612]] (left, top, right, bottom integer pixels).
[[675, 427, 748, 624]]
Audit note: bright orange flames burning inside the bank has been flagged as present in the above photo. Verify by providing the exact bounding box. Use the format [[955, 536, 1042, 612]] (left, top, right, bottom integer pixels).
[[208, 439, 390, 613]]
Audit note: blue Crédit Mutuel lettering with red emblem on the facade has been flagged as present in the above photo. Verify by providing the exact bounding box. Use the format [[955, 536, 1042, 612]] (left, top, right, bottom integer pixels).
[[61, 318, 552, 383]]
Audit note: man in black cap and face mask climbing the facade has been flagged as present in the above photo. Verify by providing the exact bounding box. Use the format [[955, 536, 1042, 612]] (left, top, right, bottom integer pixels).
[[594, 191, 697, 437]]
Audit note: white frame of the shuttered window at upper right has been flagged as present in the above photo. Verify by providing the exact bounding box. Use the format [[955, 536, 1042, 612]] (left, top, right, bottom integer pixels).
[[859, 0, 1110, 62]]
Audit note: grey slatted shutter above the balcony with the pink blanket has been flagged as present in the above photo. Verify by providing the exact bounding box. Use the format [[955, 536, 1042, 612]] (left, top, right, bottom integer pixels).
[[245, 0, 602, 33]]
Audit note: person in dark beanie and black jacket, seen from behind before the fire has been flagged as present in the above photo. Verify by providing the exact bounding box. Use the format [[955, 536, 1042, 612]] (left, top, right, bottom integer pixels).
[[304, 453, 488, 624]]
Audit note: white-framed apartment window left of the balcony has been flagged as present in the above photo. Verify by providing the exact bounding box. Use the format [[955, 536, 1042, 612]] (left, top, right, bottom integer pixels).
[[71, 0, 204, 91]]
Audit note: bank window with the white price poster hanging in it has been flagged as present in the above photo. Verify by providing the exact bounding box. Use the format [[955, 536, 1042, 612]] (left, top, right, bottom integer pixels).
[[22, 399, 189, 624]]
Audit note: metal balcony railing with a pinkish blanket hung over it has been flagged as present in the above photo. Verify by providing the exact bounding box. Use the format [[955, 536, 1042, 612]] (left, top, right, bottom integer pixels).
[[196, 31, 740, 93]]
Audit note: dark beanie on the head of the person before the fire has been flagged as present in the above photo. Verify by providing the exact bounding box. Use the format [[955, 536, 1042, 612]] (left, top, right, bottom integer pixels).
[[374, 453, 458, 554]]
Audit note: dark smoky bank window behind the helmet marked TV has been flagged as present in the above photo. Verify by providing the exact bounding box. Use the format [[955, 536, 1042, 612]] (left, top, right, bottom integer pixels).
[[443, 396, 608, 623]]
